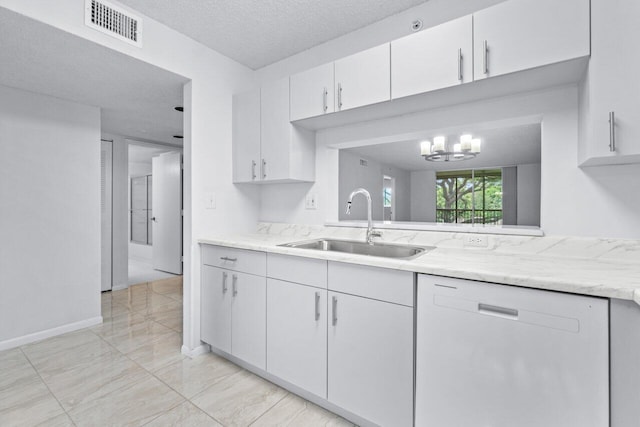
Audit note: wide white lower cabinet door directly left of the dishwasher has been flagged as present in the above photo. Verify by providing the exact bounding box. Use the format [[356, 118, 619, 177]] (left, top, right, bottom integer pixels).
[[327, 292, 413, 427]]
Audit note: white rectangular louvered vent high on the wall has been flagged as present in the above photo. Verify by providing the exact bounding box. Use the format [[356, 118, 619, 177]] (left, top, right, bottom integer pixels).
[[84, 0, 142, 47]]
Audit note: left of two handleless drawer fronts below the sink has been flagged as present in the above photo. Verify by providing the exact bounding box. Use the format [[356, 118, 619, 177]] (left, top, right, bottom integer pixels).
[[267, 253, 327, 289]]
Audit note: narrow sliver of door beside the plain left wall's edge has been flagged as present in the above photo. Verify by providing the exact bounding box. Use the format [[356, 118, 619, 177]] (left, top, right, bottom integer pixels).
[[100, 140, 113, 292]]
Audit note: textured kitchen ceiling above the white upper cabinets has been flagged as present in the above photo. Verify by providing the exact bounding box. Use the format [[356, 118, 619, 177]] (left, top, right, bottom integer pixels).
[[120, 0, 425, 69]]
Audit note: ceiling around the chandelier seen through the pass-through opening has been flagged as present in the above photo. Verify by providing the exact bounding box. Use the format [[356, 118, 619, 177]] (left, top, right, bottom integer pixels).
[[347, 124, 541, 171]]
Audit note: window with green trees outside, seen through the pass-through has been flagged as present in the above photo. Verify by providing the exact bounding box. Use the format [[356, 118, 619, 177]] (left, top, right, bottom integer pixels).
[[436, 169, 502, 225]]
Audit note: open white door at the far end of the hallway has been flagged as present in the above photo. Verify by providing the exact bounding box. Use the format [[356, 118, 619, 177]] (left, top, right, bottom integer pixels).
[[152, 152, 182, 274]]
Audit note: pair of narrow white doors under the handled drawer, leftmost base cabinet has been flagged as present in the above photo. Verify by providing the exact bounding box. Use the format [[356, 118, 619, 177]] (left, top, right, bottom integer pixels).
[[200, 265, 266, 369]]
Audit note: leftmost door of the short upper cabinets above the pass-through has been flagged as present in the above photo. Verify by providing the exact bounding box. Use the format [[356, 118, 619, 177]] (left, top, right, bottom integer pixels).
[[290, 62, 335, 121]]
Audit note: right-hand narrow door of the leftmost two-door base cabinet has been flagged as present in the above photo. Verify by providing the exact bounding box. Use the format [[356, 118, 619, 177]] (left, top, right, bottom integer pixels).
[[229, 272, 267, 369]]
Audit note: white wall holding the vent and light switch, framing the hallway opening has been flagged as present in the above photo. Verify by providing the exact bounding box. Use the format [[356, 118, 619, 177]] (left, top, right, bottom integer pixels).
[[0, 0, 260, 350]]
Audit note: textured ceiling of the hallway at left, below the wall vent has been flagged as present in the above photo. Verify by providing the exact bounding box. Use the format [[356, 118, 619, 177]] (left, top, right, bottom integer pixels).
[[0, 8, 187, 145]]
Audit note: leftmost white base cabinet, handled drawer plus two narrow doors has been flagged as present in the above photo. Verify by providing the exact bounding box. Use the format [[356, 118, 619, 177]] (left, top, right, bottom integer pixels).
[[200, 246, 266, 369]]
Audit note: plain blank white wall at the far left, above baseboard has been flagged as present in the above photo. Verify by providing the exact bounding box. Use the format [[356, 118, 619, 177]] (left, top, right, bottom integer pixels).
[[0, 86, 101, 350]]
